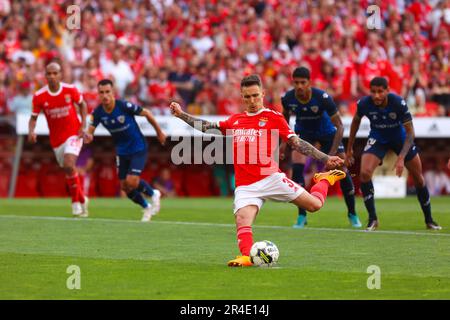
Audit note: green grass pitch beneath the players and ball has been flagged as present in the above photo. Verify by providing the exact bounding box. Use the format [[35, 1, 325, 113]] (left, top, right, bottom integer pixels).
[[0, 197, 450, 300]]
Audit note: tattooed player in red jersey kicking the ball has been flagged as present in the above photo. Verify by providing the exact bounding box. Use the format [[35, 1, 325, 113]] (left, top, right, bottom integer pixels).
[[170, 75, 345, 267]]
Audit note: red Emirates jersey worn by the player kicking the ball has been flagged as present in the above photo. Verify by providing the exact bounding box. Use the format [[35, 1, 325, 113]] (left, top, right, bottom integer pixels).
[[219, 108, 295, 187]]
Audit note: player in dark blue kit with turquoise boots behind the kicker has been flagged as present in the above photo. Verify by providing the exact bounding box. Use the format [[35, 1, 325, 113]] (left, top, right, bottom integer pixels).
[[281, 67, 361, 229]]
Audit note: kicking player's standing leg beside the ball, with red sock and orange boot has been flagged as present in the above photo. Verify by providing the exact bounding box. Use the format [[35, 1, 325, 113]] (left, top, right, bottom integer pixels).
[[228, 205, 258, 267]]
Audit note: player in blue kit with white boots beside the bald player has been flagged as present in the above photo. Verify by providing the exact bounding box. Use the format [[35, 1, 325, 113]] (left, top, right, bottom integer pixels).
[[85, 79, 166, 222]]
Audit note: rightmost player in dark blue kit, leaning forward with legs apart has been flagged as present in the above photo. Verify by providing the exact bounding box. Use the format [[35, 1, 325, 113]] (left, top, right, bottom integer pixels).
[[346, 77, 442, 231]]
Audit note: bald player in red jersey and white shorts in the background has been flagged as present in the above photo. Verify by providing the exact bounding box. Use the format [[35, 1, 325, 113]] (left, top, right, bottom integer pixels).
[[28, 62, 88, 217]]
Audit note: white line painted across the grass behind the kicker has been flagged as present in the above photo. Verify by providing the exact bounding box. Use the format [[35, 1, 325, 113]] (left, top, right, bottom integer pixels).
[[0, 215, 450, 237]]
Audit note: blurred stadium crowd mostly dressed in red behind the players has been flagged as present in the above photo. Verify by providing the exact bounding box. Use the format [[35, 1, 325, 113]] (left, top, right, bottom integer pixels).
[[0, 0, 450, 116]]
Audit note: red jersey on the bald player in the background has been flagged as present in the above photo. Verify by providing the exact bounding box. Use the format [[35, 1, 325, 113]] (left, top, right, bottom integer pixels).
[[32, 82, 83, 148]]
